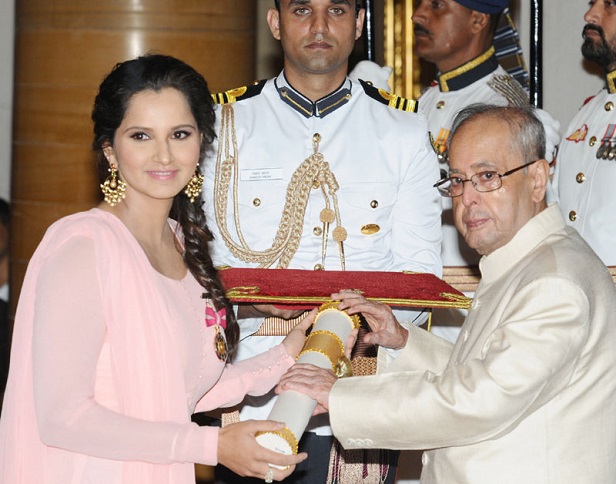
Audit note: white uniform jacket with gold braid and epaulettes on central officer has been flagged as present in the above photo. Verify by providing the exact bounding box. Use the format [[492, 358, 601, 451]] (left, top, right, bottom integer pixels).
[[204, 72, 442, 484]]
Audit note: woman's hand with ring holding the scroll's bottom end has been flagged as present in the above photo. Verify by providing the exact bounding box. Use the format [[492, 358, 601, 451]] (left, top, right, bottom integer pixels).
[[218, 420, 308, 481]]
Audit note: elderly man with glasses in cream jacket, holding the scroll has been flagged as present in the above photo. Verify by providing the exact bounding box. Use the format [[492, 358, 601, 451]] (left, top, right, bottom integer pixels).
[[279, 105, 616, 484]]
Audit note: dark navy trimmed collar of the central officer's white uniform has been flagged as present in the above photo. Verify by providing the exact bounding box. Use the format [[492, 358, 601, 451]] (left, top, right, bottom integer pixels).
[[274, 72, 352, 118]]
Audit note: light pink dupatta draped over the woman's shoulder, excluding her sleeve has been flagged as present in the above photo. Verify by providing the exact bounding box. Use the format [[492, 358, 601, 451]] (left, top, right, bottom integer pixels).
[[0, 209, 195, 484]]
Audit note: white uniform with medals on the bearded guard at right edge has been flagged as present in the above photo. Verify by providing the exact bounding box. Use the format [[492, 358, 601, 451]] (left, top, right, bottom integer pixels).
[[554, 71, 616, 266]]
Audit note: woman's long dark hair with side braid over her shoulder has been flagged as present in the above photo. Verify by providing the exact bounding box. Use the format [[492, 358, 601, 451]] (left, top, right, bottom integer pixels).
[[92, 54, 239, 357]]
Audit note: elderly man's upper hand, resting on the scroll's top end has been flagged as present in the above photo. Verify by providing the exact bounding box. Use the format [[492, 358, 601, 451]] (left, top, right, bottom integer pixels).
[[332, 290, 408, 349]]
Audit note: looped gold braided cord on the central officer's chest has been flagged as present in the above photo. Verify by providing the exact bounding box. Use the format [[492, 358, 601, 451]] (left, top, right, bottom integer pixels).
[[214, 104, 346, 270]]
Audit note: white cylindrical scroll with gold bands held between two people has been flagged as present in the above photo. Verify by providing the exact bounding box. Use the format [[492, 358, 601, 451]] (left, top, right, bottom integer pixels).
[[256, 301, 359, 467]]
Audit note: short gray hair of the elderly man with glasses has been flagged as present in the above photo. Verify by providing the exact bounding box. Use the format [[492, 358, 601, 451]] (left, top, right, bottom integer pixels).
[[447, 103, 545, 163]]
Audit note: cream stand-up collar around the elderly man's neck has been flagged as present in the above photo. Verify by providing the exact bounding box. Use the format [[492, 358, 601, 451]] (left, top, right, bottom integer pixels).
[[479, 203, 566, 284]]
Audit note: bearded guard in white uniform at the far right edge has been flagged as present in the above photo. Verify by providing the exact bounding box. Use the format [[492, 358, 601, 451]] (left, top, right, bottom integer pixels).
[[554, 2, 616, 266]]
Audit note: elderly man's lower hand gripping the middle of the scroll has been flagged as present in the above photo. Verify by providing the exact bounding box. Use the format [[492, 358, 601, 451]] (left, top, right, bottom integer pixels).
[[276, 363, 338, 415]]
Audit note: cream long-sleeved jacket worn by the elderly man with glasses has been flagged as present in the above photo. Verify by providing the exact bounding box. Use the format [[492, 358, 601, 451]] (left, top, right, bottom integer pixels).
[[329, 205, 616, 484]]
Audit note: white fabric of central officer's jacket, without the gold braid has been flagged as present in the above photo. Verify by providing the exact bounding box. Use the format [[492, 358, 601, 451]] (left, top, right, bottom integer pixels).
[[204, 73, 442, 432]]
